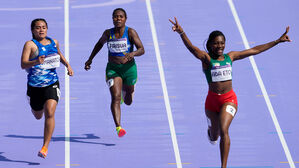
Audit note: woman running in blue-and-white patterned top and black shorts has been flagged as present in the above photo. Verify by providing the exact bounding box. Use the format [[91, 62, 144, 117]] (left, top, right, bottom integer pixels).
[[21, 18, 73, 158]]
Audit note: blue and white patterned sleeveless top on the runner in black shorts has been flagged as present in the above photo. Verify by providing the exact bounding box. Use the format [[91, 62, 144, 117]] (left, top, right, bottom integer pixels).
[[27, 37, 60, 87]]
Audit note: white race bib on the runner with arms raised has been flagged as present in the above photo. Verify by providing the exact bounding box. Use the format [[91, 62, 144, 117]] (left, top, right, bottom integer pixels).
[[211, 65, 232, 82]]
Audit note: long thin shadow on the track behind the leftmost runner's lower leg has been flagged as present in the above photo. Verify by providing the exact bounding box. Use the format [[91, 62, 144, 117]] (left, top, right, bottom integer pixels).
[[4, 134, 115, 146]]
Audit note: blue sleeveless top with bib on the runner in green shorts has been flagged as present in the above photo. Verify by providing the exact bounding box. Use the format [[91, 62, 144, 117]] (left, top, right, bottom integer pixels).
[[107, 26, 133, 57]]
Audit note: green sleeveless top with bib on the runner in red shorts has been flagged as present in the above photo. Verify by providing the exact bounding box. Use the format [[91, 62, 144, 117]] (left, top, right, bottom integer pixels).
[[204, 54, 232, 83]]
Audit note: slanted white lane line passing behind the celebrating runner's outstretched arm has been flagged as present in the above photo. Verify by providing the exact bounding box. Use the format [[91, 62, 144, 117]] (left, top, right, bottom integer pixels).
[[228, 0, 295, 168]]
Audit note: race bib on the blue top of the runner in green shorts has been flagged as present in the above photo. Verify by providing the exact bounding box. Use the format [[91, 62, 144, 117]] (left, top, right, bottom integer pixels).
[[108, 38, 128, 53]]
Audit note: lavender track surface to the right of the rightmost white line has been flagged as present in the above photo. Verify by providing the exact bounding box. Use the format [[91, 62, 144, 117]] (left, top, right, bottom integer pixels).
[[236, 0, 299, 167]]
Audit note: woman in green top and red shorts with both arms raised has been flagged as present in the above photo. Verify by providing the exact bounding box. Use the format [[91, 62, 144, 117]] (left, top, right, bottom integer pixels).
[[169, 18, 291, 168]]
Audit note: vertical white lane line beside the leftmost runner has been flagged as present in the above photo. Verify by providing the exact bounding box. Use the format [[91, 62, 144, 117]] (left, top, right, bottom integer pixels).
[[64, 0, 70, 168]]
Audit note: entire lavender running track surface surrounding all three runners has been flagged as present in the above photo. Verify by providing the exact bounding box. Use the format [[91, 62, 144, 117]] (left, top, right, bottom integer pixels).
[[0, 0, 299, 168]]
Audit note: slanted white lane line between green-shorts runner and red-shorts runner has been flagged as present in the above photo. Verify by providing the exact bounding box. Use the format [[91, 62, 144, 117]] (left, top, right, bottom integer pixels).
[[146, 0, 182, 168]]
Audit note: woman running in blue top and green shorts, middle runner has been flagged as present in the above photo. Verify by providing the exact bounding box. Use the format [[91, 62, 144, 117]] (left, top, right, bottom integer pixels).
[[85, 8, 144, 137]]
